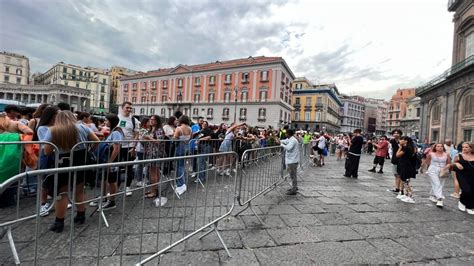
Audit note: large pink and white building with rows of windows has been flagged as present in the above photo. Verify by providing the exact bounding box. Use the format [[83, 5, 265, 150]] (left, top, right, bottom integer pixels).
[[120, 56, 294, 127]]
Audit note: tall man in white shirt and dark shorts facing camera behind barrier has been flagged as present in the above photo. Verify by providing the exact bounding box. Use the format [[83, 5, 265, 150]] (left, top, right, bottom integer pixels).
[[118, 102, 140, 196]]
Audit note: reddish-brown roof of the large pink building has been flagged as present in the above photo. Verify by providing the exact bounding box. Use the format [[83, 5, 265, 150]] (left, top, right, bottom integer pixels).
[[122, 56, 294, 80]]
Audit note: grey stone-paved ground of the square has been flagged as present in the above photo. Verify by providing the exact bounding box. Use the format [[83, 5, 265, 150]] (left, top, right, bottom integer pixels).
[[0, 156, 474, 265]]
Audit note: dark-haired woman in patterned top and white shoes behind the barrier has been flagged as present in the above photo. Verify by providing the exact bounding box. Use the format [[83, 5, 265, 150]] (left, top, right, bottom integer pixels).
[[144, 115, 168, 206]]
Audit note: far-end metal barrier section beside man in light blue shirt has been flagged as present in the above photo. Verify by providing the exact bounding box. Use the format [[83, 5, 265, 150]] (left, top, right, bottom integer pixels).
[[235, 146, 286, 224]]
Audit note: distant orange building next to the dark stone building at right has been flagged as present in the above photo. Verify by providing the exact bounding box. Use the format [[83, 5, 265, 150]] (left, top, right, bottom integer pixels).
[[388, 88, 415, 131]]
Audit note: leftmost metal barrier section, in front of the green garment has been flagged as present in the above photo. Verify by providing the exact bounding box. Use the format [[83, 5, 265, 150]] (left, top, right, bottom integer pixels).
[[0, 141, 59, 264]]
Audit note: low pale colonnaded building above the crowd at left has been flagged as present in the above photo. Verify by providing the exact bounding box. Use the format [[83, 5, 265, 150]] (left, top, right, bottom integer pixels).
[[0, 84, 90, 111]]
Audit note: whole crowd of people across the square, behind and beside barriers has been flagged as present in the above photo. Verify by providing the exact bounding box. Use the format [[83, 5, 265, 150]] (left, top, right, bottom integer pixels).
[[0, 102, 474, 232]]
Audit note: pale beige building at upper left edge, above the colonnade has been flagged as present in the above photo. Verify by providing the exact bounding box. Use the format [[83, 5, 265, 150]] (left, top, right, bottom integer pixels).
[[0, 52, 30, 85]]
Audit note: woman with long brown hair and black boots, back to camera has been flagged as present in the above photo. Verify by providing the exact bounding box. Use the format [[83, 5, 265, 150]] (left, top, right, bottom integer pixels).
[[44, 111, 99, 233]]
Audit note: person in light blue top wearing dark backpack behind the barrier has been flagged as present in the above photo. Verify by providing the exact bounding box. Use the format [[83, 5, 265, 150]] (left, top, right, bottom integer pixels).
[[89, 114, 125, 211]]
